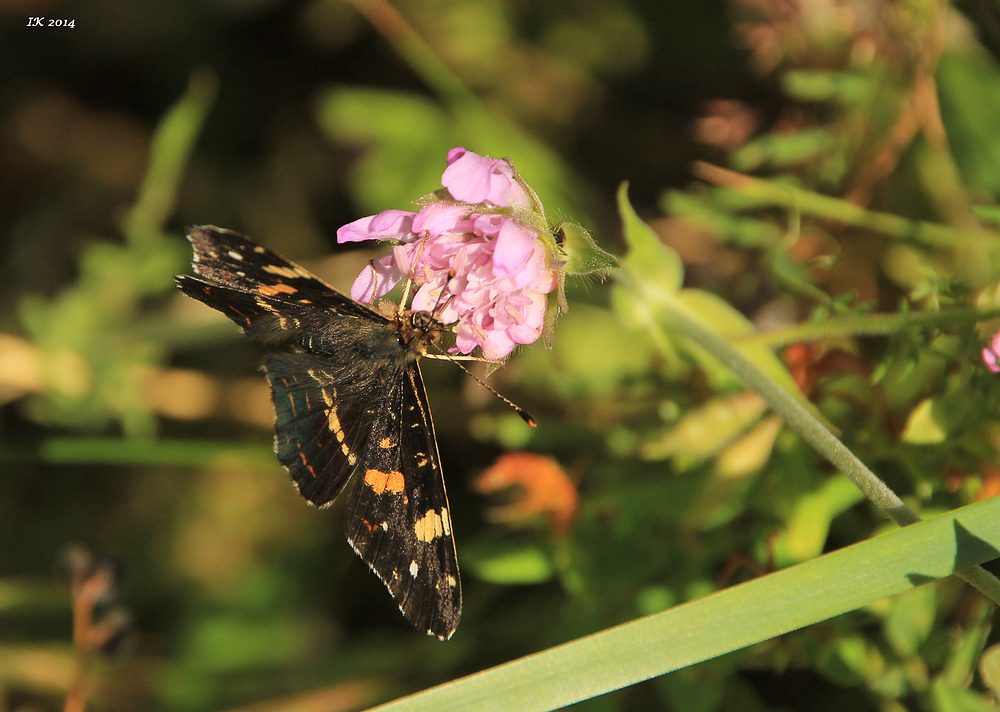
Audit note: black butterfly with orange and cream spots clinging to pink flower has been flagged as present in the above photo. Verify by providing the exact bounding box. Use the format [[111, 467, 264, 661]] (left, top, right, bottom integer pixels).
[[176, 225, 462, 640]]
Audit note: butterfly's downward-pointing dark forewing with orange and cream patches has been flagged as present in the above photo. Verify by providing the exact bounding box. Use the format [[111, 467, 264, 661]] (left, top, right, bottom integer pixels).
[[346, 363, 462, 640]]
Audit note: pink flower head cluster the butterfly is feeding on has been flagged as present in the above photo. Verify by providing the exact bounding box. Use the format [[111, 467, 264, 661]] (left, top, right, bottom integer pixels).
[[337, 148, 559, 361]]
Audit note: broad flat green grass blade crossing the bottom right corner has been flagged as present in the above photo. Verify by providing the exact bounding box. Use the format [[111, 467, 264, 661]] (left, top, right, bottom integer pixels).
[[377, 497, 1000, 712]]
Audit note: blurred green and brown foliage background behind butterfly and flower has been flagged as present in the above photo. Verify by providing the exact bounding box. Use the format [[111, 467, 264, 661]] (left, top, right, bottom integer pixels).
[[7, 0, 1000, 712]]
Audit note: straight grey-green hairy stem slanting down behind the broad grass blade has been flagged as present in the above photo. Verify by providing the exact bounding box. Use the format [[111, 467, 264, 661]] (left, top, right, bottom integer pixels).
[[651, 290, 1000, 604]]
